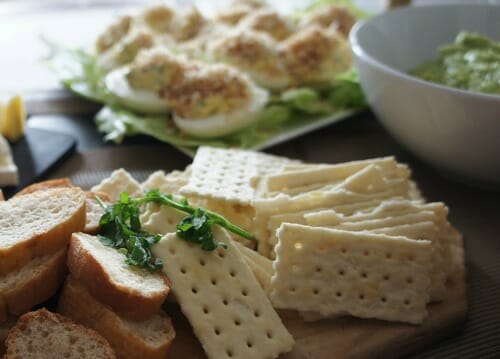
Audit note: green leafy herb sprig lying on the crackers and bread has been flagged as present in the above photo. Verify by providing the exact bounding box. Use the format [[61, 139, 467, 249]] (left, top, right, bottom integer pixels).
[[97, 190, 253, 270]]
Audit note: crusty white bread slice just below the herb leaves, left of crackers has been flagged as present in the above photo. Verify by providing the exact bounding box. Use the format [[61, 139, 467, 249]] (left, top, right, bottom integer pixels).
[[68, 233, 170, 320]]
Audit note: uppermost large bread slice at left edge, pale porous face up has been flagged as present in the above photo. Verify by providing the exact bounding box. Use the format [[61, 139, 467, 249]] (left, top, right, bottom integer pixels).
[[0, 188, 85, 276]]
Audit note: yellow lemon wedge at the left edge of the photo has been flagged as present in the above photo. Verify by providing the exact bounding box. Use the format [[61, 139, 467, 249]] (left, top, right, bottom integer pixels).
[[0, 95, 26, 142]]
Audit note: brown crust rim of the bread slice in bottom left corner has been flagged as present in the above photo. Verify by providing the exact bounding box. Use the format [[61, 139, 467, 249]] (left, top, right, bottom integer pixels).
[[4, 308, 116, 359]]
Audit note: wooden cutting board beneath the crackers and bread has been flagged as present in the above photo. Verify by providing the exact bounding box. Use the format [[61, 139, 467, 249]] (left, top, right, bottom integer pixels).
[[169, 238, 467, 359]]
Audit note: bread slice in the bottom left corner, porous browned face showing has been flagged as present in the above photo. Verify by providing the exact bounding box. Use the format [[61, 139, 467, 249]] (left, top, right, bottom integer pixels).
[[4, 308, 116, 359]]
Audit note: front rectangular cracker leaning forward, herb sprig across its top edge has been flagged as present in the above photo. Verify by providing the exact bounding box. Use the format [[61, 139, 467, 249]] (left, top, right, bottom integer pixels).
[[153, 226, 294, 359]]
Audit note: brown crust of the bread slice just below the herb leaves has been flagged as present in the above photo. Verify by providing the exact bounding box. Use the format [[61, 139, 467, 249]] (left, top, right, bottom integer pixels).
[[67, 233, 169, 320]]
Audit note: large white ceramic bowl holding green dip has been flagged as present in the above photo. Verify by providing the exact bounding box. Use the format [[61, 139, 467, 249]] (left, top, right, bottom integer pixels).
[[350, 5, 500, 188]]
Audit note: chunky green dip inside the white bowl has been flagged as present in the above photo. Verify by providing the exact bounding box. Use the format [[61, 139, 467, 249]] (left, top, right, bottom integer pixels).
[[410, 31, 500, 95]]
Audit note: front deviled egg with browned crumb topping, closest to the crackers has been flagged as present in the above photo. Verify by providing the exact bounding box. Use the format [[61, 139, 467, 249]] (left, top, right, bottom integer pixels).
[[165, 64, 269, 138]]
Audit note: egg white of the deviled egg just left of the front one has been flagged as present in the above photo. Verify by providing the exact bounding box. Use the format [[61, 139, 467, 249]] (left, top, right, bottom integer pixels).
[[104, 67, 170, 114]]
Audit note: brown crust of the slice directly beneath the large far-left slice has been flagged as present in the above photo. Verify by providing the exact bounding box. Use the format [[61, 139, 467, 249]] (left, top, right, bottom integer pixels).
[[0, 248, 67, 315]]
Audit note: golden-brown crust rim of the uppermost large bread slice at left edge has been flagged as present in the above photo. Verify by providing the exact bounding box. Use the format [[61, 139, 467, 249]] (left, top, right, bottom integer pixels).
[[0, 188, 86, 276]]
